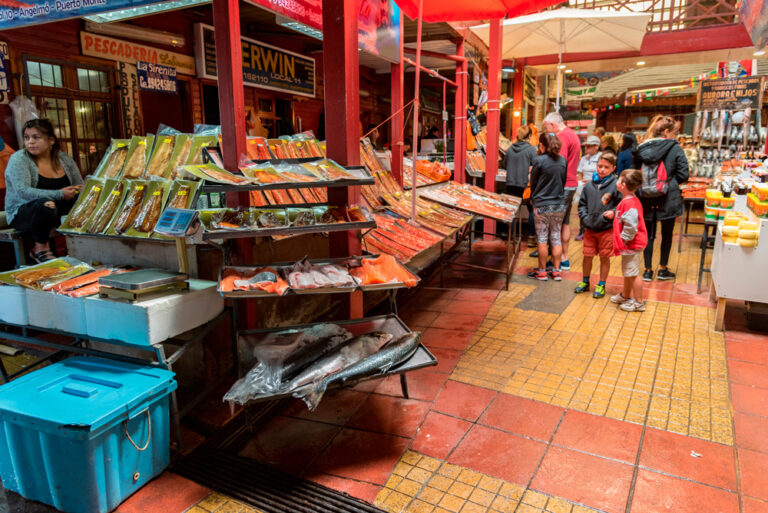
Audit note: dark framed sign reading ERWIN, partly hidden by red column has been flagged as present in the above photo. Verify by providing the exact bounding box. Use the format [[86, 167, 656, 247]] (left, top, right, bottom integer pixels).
[[195, 23, 315, 98]]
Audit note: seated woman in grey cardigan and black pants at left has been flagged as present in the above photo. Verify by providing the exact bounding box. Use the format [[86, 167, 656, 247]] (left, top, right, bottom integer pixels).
[[5, 119, 83, 262]]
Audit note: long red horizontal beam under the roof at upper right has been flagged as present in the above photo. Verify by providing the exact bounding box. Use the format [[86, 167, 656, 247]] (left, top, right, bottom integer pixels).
[[525, 23, 753, 66]]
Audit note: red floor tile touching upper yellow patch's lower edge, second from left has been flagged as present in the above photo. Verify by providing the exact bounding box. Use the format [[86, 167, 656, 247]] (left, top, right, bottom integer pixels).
[[478, 394, 565, 441]]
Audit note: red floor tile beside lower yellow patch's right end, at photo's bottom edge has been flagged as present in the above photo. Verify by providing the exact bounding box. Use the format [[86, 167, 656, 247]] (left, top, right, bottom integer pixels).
[[531, 447, 633, 513]]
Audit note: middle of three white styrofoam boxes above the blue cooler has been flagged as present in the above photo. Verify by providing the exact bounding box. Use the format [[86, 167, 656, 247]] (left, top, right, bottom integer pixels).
[[27, 290, 87, 335]]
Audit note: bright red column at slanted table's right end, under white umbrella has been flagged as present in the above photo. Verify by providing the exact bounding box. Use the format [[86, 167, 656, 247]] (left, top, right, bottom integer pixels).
[[484, 20, 501, 233]]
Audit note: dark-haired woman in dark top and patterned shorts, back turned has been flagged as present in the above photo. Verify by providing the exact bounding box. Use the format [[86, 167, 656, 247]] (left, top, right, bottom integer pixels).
[[528, 132, 567, 281]]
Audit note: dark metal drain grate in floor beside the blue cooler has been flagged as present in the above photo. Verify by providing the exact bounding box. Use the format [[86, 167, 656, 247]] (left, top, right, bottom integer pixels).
[[176, 449, 384, 513]]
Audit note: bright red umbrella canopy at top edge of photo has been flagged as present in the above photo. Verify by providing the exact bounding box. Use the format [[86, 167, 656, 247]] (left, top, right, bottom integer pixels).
[[395, 0, 563, 23]]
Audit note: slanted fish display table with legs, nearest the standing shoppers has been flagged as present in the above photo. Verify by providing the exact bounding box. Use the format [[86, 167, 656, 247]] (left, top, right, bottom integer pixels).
[[421, 181, 522, 289]]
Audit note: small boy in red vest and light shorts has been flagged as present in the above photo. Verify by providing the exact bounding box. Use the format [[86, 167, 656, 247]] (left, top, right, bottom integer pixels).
[[603, 169, 648, 312]]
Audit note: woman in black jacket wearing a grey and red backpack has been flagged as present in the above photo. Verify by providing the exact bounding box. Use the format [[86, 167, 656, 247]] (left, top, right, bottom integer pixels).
[[634, 114, 688, 281]]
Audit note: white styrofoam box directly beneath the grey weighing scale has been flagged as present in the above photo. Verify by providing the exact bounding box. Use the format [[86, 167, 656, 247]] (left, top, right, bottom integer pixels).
[[85, 280, 224, 346]]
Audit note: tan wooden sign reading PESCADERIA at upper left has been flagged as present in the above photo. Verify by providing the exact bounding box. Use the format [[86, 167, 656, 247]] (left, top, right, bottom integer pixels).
[[80, 32, 195, 75]]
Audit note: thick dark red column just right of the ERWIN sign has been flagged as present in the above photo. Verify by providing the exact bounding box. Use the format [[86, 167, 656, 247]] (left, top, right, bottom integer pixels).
[[323, 0, 363, 318]]
